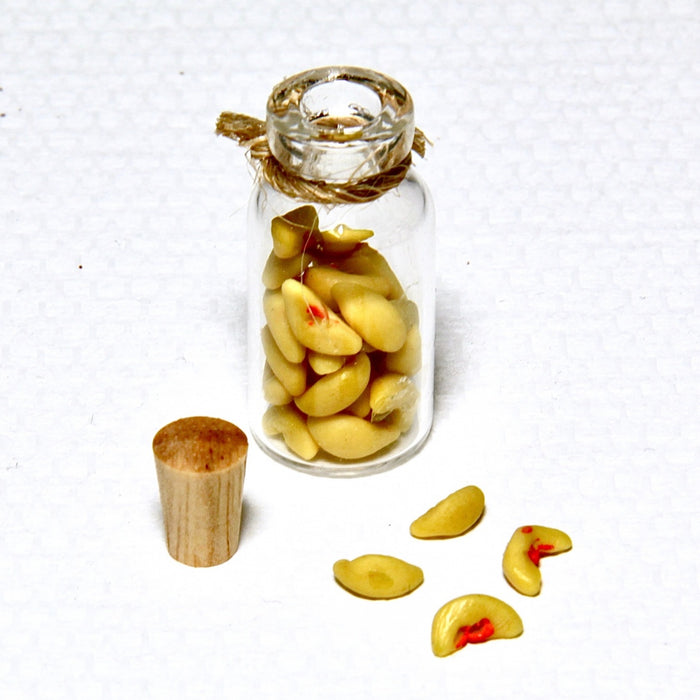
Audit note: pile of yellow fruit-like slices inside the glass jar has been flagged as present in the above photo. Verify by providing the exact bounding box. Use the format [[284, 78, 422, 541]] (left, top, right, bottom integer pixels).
[[261, 205, 421, 460]]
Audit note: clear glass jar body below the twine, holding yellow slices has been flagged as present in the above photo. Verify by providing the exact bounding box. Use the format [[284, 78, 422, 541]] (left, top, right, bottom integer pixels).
[[248, 168, 435, 476]]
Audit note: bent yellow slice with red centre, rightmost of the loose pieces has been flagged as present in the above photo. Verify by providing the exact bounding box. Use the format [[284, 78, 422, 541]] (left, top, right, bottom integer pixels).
[[503, 525, 572, 596]]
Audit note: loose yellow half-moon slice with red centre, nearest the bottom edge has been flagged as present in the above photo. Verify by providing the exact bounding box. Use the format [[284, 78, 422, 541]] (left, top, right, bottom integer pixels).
[[431, 593, 523, 656]]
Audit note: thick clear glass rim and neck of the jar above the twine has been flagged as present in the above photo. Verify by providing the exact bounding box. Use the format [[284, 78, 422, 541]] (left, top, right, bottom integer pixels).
[[267, 67, 414, 182]]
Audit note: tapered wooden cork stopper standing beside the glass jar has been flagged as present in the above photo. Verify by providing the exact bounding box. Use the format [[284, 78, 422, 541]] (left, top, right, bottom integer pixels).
[[153, 417, 248, 566]]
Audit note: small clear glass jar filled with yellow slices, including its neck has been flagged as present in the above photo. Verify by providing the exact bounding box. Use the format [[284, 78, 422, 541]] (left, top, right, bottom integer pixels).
[[248, 67, 435, 476]]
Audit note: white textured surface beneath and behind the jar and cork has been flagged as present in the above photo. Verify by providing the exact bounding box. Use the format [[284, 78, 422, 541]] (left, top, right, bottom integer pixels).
[[0, 0, 700, 700]]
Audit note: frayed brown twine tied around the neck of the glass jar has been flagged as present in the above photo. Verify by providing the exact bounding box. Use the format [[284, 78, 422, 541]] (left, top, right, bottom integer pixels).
[[216, 112, 429, 204]]
